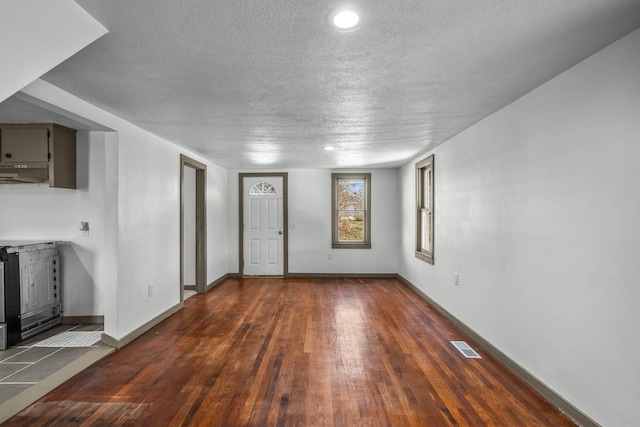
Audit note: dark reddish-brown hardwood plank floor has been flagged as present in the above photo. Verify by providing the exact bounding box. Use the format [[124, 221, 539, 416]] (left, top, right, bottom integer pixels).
[[6, 278, 574, 427]]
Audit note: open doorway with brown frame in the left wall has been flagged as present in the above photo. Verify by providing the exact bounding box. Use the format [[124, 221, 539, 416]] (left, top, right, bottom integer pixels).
[[180, 155, 207, 302]]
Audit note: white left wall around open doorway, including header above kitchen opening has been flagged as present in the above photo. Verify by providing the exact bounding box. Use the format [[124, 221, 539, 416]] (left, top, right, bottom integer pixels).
[[16, 80, 227, 339]]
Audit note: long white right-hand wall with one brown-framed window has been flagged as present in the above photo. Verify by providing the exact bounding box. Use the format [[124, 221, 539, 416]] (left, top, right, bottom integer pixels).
[[399, 30, 640, 426]]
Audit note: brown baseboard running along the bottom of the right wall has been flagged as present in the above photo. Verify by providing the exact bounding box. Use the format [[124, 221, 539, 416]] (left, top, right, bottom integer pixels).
[[396, 274, 601, 427]]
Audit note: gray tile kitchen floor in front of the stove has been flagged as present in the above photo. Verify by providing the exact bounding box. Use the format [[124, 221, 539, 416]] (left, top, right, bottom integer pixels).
[[0, 325, 103, 404]]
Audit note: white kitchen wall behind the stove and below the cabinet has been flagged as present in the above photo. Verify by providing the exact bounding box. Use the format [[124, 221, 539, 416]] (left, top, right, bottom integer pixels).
[[0, 132, 106, 316]]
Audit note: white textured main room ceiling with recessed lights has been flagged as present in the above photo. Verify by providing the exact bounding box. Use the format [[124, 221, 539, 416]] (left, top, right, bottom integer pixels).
[[12, 0, 640, 168]]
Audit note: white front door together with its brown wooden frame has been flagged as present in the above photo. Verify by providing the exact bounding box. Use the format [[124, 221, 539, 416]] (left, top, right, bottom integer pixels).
[[238, 172, 289, 277]]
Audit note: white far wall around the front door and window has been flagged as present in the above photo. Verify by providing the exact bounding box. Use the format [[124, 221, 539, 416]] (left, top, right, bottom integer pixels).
[[227, 169, 399, 273]]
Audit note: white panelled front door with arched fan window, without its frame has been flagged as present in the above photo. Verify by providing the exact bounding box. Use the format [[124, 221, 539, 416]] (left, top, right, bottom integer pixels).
[[242, 176, 285, 276]]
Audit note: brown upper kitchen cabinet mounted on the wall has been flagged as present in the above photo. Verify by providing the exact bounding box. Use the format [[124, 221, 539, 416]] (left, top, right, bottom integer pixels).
[[0, 124, 76, 188]]
